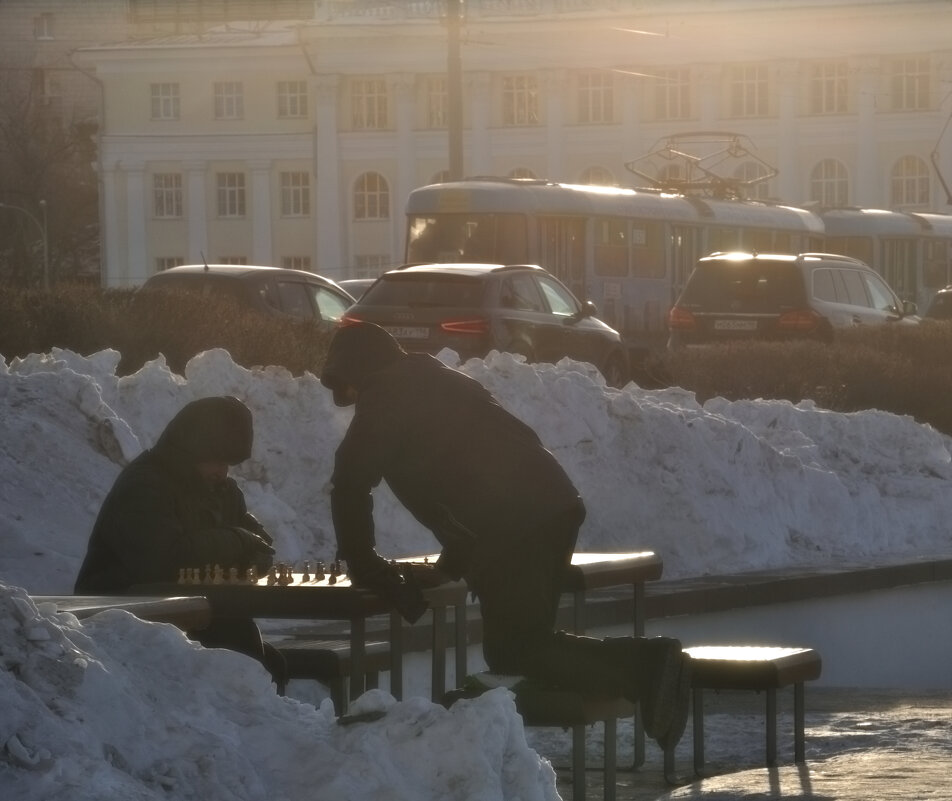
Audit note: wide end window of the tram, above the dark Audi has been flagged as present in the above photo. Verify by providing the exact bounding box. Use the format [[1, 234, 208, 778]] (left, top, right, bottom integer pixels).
[[407, 214, 529, 264]]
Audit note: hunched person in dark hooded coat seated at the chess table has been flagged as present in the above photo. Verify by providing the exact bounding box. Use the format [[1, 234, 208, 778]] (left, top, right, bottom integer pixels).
[[75, 397, 283, 681]]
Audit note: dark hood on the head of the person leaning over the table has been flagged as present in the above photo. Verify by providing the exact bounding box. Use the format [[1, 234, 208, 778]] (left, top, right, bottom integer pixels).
[[321, 323, 406, 406]]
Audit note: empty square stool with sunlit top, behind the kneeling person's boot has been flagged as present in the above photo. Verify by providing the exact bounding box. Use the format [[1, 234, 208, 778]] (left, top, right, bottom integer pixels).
[[680, 645, 822, 775]]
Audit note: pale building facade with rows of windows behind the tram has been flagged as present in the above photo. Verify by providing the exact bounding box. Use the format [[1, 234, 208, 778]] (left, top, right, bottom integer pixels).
[[75, 0, 952, 287]]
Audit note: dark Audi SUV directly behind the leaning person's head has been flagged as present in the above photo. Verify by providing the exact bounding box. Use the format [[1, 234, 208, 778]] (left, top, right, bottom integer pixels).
[[344, 263, 628, 386]]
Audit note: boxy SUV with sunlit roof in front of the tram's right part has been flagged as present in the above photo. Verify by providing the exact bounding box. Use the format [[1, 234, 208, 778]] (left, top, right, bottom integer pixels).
[[668, 252, 919, 348]]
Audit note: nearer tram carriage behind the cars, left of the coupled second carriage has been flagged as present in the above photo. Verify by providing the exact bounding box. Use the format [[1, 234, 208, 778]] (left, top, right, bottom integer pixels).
[[405, 177, 824, 359]]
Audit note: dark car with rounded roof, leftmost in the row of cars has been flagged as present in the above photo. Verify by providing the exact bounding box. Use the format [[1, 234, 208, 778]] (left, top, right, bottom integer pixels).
[[140, 264, 354, 329]]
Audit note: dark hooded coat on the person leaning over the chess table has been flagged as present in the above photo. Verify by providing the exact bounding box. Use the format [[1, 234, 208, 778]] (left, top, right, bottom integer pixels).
[[322, 326, 584, 581]]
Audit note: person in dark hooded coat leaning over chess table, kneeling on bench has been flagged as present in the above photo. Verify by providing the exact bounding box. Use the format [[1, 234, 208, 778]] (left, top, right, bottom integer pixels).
[[321, 323, 689, 747]]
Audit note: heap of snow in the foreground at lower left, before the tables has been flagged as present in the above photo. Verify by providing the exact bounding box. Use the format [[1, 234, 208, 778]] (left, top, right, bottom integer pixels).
[[0, 585, 558, 801]]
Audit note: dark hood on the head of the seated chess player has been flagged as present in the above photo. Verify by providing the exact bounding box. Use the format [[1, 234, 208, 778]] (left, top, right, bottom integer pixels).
[[153, 396, 254, 465]]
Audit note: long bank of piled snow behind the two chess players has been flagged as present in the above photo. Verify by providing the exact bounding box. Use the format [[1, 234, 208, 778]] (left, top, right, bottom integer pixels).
[[0, 350, 952, 594]]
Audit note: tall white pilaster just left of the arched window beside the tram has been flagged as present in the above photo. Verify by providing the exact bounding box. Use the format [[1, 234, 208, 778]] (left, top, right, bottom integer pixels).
[[312, 75, 349, 278]]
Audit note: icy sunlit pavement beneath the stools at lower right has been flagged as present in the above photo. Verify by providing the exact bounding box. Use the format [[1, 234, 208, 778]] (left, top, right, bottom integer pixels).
[[540, 686, 952, 801]]
